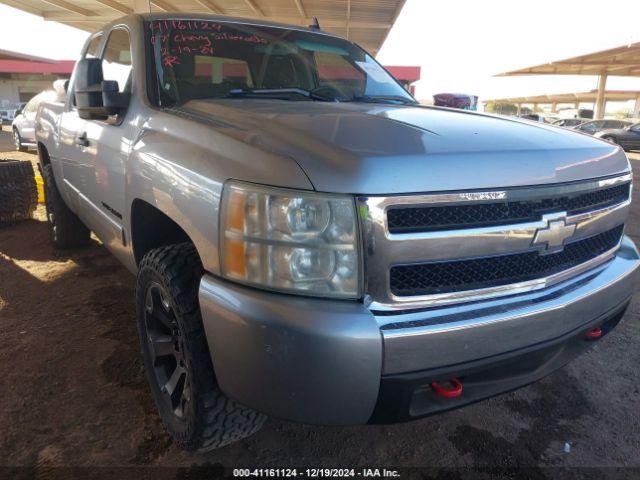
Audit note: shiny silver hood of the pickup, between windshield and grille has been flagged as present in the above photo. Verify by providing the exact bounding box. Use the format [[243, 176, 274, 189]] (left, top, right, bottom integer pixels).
[[180, 99, 628, 195]]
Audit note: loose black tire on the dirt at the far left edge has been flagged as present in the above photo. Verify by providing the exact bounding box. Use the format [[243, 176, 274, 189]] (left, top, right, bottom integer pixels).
[[0, 160, 38, 225]]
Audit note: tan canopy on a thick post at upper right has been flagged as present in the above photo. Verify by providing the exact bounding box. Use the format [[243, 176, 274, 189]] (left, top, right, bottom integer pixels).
[[497, 42, 640, 118]]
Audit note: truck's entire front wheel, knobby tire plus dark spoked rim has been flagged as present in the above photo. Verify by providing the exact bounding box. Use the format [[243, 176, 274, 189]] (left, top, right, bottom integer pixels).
[[136, 243, 266, 452]]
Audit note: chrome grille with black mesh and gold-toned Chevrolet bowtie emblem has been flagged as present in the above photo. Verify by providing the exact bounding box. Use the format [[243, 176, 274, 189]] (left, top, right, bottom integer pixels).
[[358, 174, 631, 311]]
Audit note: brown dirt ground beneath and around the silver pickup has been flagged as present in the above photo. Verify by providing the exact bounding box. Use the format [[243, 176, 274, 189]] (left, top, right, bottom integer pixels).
[[0, 127, 640, 479]]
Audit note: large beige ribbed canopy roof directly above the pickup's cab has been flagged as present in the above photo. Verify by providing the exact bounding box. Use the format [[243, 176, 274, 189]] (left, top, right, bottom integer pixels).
[[0, 0, 406, 55]]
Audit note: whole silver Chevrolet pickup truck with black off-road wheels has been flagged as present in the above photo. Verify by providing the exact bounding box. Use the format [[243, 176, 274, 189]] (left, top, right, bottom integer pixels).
[[36, 14, 640, 451]]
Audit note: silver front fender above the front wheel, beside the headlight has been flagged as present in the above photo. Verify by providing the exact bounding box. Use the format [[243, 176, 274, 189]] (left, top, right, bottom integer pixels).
[[127, 112, 313, 274]]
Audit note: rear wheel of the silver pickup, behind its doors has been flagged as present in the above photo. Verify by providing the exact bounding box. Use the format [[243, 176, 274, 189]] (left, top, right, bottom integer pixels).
[[42, 164, 91, 249]]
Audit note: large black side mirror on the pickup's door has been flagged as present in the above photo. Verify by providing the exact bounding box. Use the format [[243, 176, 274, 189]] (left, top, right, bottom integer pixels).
[[75, 58, 131, 120]]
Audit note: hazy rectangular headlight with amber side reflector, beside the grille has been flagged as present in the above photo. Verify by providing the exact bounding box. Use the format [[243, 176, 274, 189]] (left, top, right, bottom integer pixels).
[[220, 181, 360, 298]]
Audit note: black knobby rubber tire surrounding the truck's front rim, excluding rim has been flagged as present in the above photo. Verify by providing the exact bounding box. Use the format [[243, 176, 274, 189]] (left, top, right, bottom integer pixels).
[[136, 243, 266, 452]]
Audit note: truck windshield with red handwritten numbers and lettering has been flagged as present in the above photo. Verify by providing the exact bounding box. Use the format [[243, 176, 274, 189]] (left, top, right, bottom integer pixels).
[[146, 19, 415, 106]]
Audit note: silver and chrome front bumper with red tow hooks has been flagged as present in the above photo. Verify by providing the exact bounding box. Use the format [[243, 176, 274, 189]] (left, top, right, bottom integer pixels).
[[200, 237, 640, 425]]
